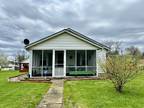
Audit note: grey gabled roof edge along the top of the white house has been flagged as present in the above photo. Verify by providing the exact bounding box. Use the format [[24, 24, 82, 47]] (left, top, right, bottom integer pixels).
[[25, 28, 110, 50]]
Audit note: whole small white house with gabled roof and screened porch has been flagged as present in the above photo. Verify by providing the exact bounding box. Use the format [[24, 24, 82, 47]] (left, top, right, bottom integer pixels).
[[25, 28, 109, 77]]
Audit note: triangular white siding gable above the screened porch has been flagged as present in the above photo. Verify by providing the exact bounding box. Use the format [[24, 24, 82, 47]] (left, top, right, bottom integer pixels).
[[31, 33, 96, 50]]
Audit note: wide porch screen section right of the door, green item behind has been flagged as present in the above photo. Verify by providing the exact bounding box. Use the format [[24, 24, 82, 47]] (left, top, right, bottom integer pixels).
[[66, 50, 96, 76]]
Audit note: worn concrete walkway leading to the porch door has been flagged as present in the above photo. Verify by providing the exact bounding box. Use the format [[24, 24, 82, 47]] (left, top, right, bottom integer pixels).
[[37, 79, 64, 108]]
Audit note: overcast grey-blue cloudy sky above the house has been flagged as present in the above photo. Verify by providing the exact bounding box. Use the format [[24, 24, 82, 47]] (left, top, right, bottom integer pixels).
[[0, 0, 144, 55]]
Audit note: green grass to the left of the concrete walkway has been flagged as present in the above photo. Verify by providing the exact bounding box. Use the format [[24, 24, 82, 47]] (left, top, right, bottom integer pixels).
[[0, 71, 50, 108]]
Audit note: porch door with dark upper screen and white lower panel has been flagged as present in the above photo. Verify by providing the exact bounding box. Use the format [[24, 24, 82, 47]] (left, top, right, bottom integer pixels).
[[54, 51, 64, 77]]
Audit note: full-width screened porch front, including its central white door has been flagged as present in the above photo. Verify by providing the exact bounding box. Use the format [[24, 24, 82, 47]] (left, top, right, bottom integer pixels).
[[32, 50, 96, 76]]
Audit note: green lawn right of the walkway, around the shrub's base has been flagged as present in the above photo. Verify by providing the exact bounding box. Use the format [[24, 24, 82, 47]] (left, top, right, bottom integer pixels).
[[64, 71, 144, 108]]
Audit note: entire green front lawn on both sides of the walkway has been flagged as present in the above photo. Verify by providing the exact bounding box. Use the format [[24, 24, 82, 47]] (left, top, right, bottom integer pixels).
[[0, 72, 144, 108]]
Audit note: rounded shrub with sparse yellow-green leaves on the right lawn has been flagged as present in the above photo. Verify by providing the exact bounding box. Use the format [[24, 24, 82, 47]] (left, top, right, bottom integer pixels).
[[101, 55, 138, 92]]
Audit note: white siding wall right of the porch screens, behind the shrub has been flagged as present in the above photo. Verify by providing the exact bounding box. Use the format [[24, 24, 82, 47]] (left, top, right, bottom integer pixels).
[[96, 50, 106, 75]]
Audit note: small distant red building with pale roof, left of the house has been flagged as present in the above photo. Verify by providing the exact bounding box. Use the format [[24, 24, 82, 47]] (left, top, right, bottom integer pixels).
[[19, 59, 29, 72]]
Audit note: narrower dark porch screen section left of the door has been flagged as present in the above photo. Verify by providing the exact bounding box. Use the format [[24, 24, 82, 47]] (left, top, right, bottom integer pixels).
[[32, 50, 52, 76]]
